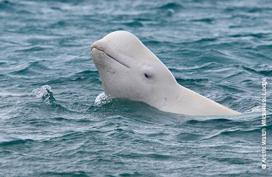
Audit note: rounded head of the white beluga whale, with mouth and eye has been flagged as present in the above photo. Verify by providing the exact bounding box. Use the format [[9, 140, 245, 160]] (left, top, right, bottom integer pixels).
[[91, 31, 177, 107]]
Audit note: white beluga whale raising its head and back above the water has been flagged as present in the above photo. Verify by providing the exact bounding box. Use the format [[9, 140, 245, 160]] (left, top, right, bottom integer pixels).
[[91, 31, 240, 116]]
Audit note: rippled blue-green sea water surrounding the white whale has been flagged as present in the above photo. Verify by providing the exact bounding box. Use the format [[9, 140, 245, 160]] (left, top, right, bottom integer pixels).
[[0, 0, 272, 177]]
